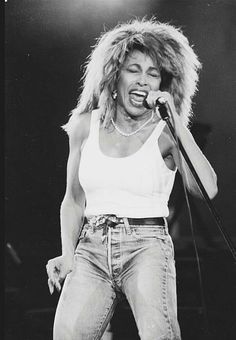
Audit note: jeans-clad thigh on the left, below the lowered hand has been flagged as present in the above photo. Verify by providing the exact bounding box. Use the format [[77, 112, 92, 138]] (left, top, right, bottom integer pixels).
[[53, 251, 116, 340]]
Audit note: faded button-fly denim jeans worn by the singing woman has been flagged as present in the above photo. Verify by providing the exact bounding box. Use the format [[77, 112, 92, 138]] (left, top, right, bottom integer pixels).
[[54, 219, 180, 340]]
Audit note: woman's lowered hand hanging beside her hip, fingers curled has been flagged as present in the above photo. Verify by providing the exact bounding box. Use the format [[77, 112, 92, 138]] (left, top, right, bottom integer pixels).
[[46, 255, 74, 294]]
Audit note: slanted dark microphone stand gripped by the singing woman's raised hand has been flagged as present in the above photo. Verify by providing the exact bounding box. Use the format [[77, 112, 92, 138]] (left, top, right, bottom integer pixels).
[[158, 102, 236, 262]]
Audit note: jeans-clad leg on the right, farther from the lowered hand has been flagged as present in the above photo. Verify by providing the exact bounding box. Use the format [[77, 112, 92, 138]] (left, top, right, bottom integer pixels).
[[123, 233, 180, 340]]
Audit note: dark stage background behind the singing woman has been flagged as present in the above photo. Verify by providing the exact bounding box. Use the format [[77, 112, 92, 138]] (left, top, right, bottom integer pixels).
[[4, 0, 236, 340]]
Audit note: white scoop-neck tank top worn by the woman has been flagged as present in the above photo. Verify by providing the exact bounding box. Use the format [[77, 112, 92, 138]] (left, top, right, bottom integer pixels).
[[79, 110, 176, 218]]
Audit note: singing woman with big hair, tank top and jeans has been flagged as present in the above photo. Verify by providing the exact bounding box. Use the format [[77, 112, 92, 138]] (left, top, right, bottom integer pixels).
[[47, 19, 217, 340]]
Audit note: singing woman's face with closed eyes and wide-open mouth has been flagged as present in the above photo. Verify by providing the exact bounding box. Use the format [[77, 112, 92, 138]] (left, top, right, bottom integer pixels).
[[117, 50, 161, 117]]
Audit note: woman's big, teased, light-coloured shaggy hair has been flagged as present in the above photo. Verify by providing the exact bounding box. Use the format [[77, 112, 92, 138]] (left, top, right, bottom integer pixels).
[[63, 17, 201, 133]]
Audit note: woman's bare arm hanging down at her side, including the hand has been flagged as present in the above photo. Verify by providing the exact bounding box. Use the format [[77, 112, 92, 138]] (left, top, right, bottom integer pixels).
[[47, 114, 90, 294]]
